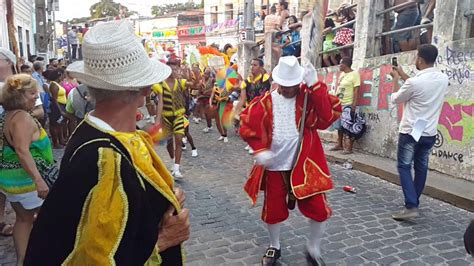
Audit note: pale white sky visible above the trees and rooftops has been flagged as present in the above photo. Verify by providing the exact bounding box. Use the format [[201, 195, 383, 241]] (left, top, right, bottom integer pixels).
[[56, 0, 193, 21]]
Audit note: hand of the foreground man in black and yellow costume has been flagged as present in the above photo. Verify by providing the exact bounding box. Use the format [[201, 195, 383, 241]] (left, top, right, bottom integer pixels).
[[157, 206, 190, 252]]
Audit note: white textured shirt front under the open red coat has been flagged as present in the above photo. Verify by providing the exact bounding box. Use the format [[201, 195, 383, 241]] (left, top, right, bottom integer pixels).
[[267, 90, 299, 171]]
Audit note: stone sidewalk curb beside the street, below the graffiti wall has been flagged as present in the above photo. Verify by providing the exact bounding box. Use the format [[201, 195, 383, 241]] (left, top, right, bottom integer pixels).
[[326, 154, 474, 212]]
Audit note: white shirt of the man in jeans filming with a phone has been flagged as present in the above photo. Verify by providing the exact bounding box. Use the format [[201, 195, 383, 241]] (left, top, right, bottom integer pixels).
[[391, 67, 449, 137]]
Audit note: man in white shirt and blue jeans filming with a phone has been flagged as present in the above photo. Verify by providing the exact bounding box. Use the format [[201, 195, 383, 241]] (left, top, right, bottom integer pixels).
[[390, 44, 449, 220]]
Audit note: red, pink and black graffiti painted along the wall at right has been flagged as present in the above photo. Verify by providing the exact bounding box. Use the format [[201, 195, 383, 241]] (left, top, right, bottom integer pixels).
[[318, 60, 474, 163]]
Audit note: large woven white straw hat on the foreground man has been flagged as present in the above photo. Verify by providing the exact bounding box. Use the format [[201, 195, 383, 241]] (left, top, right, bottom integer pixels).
[[67, 21, 171, 91]]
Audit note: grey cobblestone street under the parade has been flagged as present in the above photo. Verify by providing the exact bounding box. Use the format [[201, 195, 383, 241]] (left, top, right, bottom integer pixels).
[[0, 124, 474, 265]]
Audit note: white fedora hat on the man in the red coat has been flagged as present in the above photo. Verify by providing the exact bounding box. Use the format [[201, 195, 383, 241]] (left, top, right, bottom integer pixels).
[[272, 56, 304, 87]]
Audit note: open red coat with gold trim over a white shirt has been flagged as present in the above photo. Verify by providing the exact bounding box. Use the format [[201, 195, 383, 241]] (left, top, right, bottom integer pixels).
[[240, 82, 341, 204]]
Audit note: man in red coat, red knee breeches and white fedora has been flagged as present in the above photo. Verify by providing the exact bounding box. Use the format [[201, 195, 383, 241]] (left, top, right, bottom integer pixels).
[[240, 56, 341, 265]]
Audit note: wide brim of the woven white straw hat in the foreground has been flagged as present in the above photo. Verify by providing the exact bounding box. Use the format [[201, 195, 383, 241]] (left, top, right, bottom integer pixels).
[[66, 59, 171, 91]]
